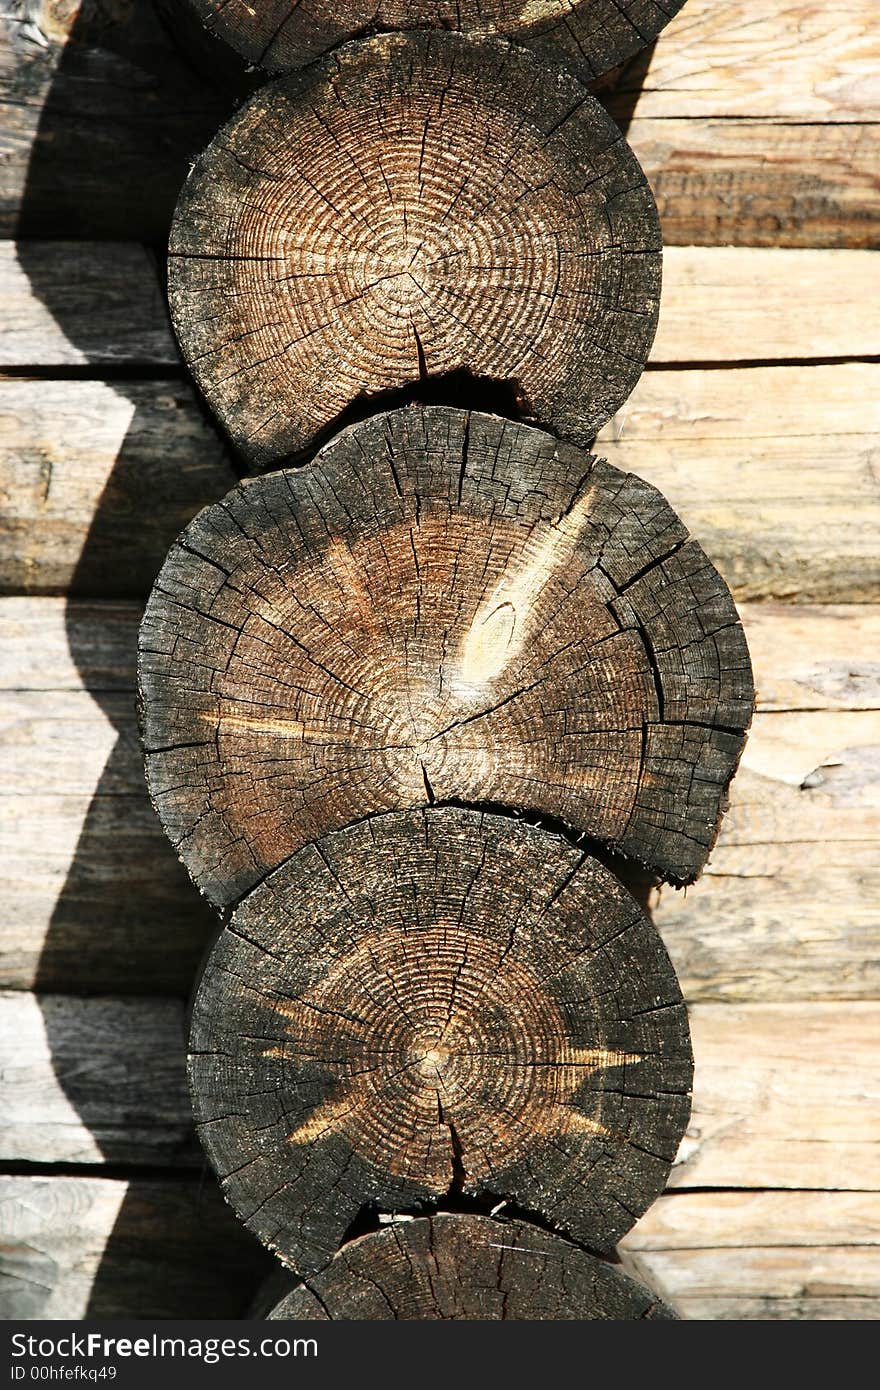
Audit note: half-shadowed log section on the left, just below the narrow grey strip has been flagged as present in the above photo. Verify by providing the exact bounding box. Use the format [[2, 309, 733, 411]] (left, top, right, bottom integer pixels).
[[0, 379, 234, 598]]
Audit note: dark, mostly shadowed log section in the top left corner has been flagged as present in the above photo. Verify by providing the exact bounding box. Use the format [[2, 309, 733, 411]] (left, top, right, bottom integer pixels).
[[0, 0, 231, 245]]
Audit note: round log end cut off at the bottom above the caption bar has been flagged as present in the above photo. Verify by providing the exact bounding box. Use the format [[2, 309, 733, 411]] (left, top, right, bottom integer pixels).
[[257, 1215, 676, 1322]]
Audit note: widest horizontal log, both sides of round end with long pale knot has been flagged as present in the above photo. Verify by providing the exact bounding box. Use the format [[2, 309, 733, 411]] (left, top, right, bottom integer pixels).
[[0, 598, 880, 1002]]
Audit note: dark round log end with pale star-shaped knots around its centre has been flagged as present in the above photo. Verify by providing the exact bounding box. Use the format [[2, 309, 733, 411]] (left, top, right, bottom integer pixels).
[[189, 808, 692, 1272]]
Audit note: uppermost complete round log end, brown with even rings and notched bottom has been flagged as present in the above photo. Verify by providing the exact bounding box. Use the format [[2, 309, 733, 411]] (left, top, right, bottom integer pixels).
[[168, 33, 660, 467]]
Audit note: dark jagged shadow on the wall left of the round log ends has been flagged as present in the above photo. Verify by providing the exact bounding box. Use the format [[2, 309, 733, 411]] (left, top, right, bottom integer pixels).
[[8, 0, 652, 1318]]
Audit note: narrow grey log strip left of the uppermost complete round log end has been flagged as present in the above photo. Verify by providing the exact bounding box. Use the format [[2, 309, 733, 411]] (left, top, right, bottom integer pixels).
[[0, 242, 179, 367]]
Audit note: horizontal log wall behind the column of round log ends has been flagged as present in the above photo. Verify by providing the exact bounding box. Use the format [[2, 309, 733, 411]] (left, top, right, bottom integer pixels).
[[0, 0, 880, 1318]]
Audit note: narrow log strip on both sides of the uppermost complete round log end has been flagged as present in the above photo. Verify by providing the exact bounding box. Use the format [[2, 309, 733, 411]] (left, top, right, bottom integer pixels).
[[8, 242, 880, 368]]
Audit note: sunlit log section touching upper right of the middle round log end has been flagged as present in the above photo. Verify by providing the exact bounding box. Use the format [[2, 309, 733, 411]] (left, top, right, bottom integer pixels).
[[595, 363, 880, 603]]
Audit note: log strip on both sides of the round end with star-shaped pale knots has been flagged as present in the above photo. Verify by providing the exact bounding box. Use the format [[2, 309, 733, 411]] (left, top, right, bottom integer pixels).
[[0, 992, 880, 1191]]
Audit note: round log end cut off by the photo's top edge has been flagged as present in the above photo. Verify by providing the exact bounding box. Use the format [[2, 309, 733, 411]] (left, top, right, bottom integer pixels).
[[188, 0, 684, 78]]
